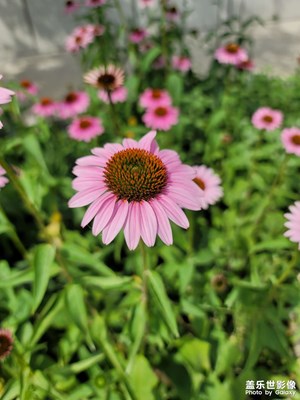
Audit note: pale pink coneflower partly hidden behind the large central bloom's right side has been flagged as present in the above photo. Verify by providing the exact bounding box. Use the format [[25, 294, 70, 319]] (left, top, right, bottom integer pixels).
[[194, 165, 223, 210]]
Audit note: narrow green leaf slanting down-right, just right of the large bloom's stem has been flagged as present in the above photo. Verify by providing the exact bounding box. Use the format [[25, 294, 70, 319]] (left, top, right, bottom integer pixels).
[[148, 271, 179, 337]]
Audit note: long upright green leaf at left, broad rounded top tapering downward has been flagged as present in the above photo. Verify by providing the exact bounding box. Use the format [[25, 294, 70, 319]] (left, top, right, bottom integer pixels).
[[32, 244, 55, 313]]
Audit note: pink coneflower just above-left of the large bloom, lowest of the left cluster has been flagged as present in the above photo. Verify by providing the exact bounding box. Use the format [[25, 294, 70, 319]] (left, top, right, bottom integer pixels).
[[67, 116, 104, 142]]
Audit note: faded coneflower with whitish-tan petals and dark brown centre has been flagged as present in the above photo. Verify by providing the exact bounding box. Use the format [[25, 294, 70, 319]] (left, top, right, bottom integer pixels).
[[83, 64, 125, 91]]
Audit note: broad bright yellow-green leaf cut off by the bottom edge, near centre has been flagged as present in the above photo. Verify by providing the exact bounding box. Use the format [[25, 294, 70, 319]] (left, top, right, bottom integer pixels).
[[130, 355, 158, 400]]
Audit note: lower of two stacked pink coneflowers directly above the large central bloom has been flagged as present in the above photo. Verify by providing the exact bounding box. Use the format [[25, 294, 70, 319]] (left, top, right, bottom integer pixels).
[[142, 105, 179, 131]]
